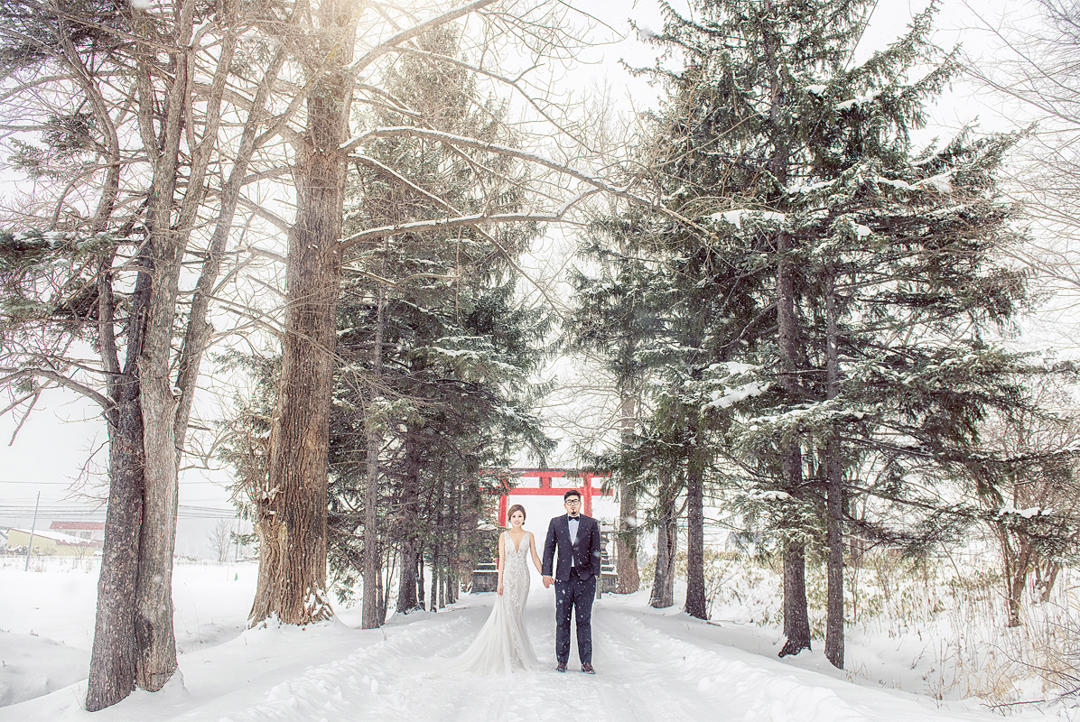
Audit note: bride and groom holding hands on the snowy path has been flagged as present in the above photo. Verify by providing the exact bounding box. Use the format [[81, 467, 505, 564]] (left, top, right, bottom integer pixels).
[[458, 489, 600, 675]]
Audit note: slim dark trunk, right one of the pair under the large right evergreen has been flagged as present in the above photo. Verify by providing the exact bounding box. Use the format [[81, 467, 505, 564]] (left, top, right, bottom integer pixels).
[[825, 270, 845, 669]]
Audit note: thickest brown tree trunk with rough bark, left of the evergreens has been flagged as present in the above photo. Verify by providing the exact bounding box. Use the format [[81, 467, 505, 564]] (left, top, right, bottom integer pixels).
[[251, 0, 355, 624]]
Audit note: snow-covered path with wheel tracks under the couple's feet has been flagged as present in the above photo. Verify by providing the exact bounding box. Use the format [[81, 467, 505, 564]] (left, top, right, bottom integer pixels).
[[150, 587, 1028, 722]]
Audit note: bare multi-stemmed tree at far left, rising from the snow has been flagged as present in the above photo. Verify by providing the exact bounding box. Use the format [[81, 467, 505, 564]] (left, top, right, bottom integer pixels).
[[0, 0, 295, 710]]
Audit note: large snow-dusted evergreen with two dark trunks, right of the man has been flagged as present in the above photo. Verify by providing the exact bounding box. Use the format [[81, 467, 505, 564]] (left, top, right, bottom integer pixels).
[[639, 0, 1023, 666]]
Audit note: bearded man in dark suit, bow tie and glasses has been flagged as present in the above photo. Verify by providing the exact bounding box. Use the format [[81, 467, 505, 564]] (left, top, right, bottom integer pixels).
[[543, 489, 600, 675]]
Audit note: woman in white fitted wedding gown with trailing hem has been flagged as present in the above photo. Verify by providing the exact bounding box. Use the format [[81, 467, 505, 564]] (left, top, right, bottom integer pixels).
[[456, 504, 540, 675]]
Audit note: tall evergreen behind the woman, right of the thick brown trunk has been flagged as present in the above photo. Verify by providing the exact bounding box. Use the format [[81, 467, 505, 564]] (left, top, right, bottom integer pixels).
[[332, 29, 548, 612]]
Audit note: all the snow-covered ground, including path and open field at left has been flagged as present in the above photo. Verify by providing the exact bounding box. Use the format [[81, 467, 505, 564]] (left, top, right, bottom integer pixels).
[[0, 560, 1070, 722]]
